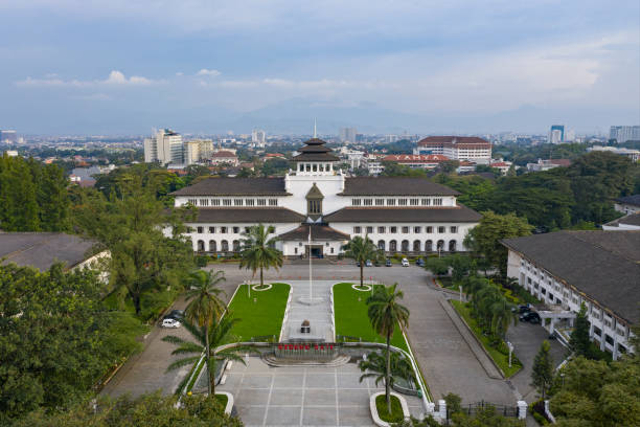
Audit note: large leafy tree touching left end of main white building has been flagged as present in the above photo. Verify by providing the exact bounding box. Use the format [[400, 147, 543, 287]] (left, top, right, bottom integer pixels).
[[74, 174, 194, 316]]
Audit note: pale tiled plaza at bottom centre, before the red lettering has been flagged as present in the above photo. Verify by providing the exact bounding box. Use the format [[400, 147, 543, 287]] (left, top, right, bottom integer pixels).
[[216, 357, 424, 427]]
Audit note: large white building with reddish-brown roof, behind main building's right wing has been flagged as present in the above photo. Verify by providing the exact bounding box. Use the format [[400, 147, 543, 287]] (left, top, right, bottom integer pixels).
[[414, 136, 491, 164]]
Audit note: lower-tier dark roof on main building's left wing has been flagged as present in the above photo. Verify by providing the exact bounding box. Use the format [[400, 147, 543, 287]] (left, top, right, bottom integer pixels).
[[187, 207, 305, 224]]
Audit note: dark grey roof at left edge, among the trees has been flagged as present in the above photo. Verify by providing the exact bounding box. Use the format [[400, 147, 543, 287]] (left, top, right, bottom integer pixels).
[[0, 232, 96, 271]]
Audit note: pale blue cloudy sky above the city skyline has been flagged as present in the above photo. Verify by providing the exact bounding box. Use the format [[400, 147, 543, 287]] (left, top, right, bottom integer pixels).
[[0, 0, 640, 134]]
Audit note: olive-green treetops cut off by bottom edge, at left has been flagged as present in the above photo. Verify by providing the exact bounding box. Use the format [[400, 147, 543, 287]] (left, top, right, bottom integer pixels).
[[14, 391, 243, 427]]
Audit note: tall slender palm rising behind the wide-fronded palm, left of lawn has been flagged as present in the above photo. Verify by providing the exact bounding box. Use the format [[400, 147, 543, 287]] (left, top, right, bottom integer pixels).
[[185, 270, 226, 393]]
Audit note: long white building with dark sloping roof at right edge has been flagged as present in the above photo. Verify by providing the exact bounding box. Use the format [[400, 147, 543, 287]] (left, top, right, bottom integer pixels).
[[502, 231, 640, 359]]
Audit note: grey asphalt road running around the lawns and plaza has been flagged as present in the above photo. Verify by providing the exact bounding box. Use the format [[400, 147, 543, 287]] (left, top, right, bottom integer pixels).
[[103, 262, 564, 405]]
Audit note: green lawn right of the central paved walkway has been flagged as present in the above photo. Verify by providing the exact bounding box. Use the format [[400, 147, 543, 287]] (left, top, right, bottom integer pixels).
[[333, 283, 409, 352]]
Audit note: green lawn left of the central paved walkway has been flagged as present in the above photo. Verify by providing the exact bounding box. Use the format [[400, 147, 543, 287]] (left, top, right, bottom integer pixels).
[[229, 283, 289, 341]]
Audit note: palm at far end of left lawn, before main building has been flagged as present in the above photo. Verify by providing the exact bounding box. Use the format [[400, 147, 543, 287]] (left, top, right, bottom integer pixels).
[[239, 224, 282, 287]]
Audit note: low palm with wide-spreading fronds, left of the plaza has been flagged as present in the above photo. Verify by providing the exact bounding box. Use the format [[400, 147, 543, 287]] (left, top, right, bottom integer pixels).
[[162, 314, 255, 396]]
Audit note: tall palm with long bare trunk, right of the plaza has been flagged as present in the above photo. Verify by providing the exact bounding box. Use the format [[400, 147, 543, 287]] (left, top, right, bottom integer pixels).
[[367, 283, 409, 413]]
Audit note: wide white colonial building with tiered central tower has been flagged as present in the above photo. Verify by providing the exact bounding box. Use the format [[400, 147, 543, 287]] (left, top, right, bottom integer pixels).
[[172, 138, 480, 257]]
